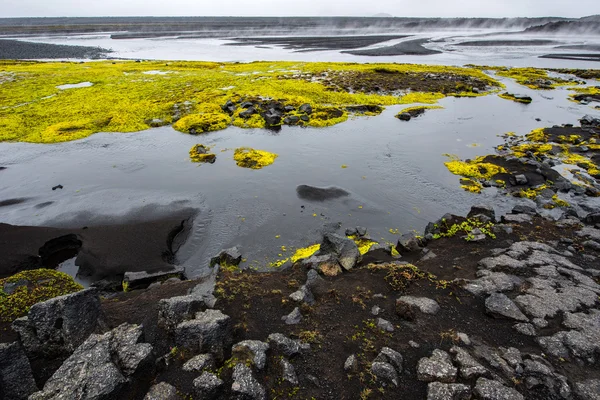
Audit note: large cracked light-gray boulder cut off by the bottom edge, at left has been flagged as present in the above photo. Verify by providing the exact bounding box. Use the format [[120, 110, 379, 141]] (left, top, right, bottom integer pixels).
[[29, 324, 152, 400]]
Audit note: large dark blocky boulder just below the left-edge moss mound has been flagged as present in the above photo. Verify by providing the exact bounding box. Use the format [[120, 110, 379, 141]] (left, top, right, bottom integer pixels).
[[12, 289, 105, 358]]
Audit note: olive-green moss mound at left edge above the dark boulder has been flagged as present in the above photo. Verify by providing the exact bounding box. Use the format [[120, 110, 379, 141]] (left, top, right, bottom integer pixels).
[[0, 269, 83, 322]]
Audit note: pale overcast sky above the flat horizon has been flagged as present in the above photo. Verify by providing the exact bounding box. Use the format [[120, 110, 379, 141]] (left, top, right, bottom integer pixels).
[[0, 0, 600, 17]]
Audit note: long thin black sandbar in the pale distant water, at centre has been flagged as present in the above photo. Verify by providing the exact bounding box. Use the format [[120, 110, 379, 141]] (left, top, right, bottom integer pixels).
[[225, 35, 407, 51]]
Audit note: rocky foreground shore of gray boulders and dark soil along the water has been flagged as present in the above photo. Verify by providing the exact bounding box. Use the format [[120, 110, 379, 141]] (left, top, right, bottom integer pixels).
[[0, 115, 600, 400]]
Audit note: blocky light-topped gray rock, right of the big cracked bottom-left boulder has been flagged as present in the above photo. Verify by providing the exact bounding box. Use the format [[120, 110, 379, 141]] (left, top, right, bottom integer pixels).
[[175, 310, 232, 361]]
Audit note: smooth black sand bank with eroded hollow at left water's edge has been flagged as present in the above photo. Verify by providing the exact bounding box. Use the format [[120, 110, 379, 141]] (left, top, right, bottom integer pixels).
[[0, 209, 196, 282]]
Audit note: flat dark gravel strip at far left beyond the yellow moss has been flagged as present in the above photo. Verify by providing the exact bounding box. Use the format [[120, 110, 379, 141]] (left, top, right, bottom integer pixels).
[[0, 39, 112, 60]]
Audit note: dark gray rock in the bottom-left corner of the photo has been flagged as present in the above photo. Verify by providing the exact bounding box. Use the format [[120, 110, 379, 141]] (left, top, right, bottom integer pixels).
[[0, 342, 38, 400]]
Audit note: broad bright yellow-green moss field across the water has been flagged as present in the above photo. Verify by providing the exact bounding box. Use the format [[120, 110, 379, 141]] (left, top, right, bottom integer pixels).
[[0, 61, 501, 143]]
